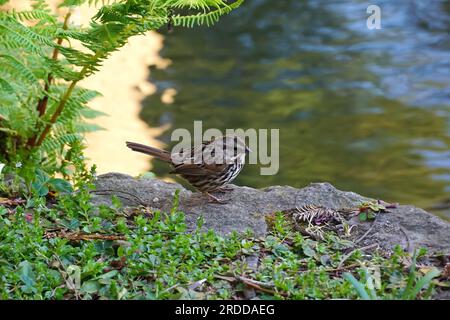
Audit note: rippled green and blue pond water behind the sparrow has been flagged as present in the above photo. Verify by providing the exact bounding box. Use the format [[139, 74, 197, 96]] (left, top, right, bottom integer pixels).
[[141, 0, 450, 217]]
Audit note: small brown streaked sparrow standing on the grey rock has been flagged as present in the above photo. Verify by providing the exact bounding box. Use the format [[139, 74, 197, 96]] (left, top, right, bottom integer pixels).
[[127, 135, 250, 203]]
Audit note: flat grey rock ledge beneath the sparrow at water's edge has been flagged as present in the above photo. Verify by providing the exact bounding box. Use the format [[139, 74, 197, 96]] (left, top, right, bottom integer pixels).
[[92, 173, 450, 253]]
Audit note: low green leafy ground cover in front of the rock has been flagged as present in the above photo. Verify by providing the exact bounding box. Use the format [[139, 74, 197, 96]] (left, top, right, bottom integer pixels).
[[0, 180, 449, 299]]
